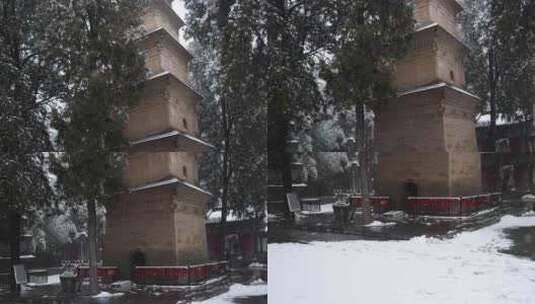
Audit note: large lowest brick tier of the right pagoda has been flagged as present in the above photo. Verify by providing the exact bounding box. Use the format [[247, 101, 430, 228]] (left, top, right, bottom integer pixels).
[[376, 89, 481, 206]]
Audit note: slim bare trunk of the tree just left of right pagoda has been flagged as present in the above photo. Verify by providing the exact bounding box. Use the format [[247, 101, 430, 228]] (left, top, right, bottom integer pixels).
[[355, 104, 372, 225]]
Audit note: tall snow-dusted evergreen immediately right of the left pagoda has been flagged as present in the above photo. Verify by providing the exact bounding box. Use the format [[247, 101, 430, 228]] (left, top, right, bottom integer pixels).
[[186, 0, 267, 255]]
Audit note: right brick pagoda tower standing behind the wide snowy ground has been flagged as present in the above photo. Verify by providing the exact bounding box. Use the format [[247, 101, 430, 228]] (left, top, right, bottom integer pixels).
[[375, 0, 481, 208]]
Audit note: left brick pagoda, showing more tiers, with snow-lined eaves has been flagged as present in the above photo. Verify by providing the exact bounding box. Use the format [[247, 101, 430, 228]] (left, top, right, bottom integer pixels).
[[104, 0, 213, 276]]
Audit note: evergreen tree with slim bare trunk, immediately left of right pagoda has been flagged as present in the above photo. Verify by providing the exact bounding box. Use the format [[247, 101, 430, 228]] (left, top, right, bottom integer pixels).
[[322, 0, 414, 224]]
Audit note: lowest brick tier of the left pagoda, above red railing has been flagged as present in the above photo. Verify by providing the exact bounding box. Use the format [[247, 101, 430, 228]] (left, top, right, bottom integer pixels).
[[104, 187, 207, 274]]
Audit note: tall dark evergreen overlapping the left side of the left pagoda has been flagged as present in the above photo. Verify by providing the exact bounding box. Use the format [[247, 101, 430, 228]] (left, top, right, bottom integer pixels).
[[55, 0, 146, 293]]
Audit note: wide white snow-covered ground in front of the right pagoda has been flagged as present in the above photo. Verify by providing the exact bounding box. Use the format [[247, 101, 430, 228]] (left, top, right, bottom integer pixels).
[[268, 216, 535, 304]]
